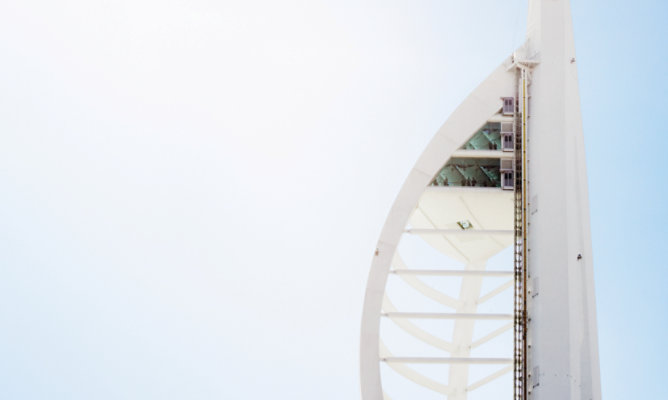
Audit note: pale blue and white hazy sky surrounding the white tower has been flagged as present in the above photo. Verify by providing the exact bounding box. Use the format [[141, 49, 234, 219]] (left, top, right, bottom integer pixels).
[[0, 0, 668, 400]]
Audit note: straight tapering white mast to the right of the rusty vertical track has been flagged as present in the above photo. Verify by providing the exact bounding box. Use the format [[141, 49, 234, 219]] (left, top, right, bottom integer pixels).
[[528, 0, 601, 400]]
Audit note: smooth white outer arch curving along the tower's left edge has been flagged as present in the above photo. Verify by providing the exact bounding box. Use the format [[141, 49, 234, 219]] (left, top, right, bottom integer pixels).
[[360, 58, 515, 400]]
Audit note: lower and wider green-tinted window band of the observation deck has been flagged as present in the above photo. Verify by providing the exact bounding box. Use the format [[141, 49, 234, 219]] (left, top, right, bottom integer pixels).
[[430, 158, 501, 187]]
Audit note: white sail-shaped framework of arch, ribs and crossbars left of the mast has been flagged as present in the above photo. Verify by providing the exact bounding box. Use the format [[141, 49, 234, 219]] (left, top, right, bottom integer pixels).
[[361, 59, 516, 400]]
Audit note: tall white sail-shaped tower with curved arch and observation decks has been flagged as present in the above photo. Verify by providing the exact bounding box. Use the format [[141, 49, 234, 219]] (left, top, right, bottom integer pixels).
[[361, 0, 601, 400]]
